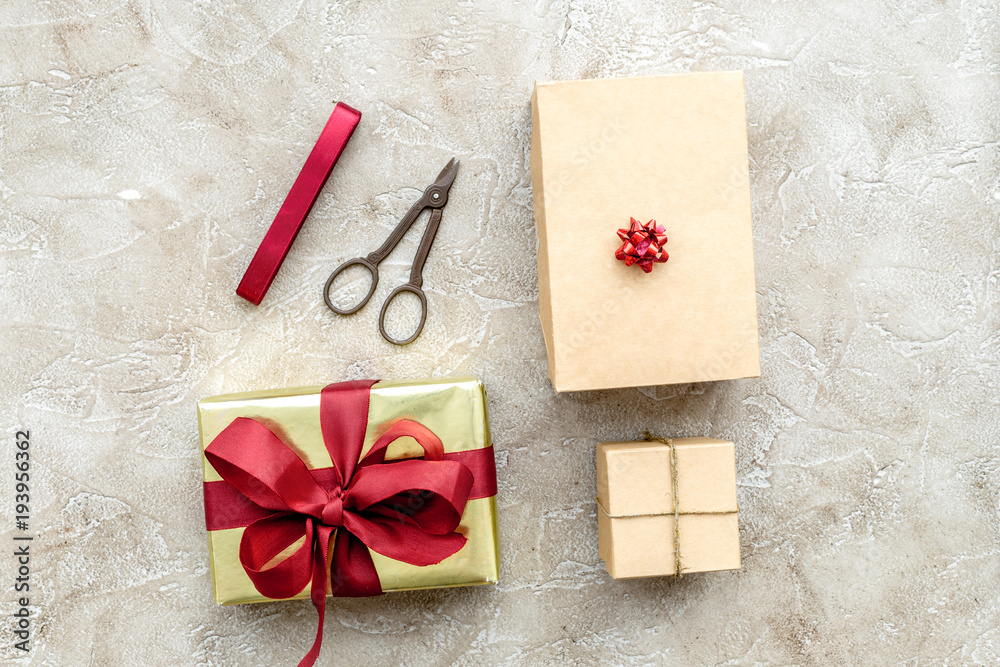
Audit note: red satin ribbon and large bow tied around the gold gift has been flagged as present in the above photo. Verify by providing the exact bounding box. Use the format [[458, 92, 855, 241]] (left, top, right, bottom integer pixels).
[[205, 380, 496, 667]]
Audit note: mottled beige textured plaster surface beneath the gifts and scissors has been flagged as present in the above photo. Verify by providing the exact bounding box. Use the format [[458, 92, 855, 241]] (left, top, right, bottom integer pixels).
[[0, 0, 1000, 666]]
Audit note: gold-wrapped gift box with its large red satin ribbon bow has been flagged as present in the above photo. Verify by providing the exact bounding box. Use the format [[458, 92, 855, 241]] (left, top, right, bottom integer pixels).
[[198, 378, 499, 665]]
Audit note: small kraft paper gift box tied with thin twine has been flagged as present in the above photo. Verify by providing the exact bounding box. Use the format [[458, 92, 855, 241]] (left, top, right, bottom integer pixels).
[[597, 438, 740, 579]]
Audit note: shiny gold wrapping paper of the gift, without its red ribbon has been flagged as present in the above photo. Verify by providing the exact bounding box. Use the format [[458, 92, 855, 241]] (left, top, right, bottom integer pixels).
[[198, 377, 500, 604]]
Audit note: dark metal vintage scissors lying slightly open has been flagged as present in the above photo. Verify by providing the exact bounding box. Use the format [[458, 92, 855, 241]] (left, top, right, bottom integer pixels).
[[323, 158, 459, 345]]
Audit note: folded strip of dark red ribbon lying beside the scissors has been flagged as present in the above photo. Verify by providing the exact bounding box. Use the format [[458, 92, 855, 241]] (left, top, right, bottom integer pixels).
[[236, 102, 361, 306]]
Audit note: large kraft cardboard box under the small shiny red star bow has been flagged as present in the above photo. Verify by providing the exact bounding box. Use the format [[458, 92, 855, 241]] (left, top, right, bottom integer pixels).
[[531, 72, 760, 391]]
